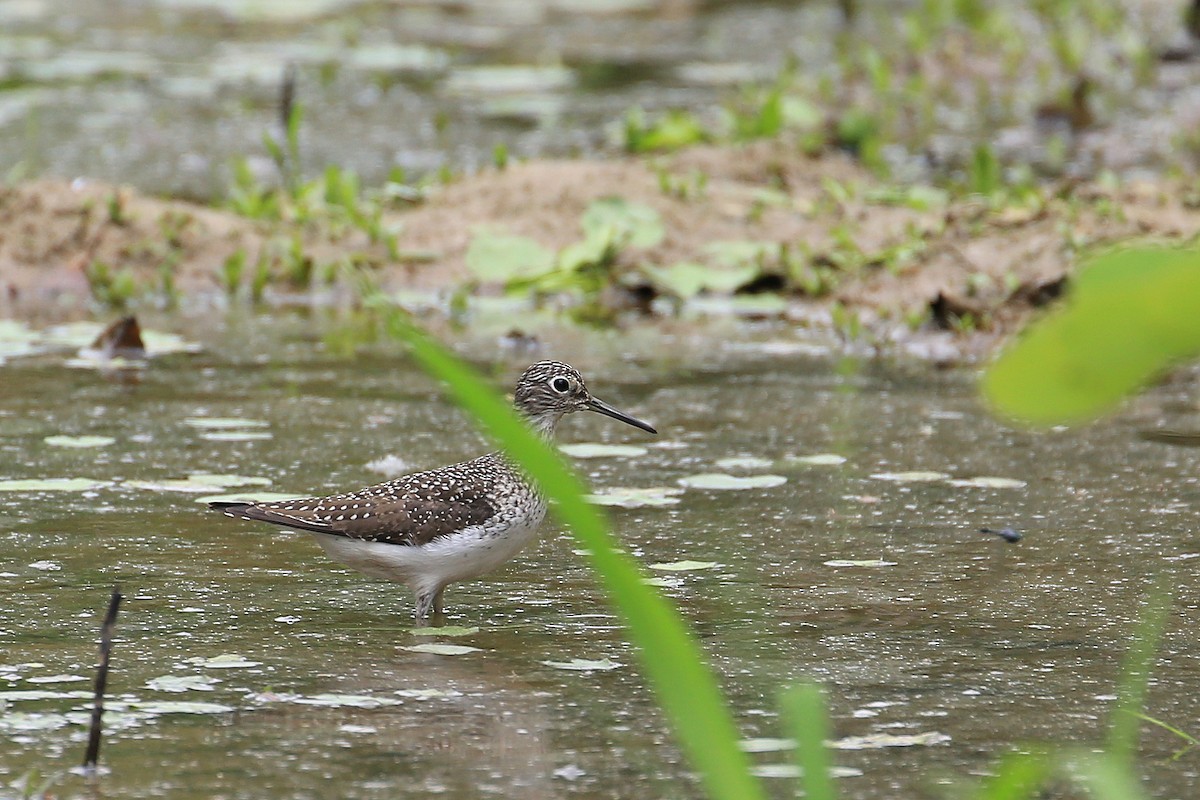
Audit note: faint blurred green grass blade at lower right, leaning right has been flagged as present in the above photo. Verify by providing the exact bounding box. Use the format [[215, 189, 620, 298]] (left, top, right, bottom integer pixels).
[[1108, 578, 1171, 764]]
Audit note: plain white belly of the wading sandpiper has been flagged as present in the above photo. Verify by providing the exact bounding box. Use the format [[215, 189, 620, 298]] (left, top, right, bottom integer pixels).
[[311, 506, 546, 593]]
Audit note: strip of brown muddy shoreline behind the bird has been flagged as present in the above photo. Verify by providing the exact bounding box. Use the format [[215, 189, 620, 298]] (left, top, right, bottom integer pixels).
[[0, 140, 1200, 342]]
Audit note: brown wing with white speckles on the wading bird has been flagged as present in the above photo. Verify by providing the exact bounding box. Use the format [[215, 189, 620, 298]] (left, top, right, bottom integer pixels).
[[210, 456, 497, 546]]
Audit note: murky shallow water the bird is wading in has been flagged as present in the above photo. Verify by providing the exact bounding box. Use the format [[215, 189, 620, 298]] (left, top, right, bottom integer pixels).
[[0, 315, 1200, 798]]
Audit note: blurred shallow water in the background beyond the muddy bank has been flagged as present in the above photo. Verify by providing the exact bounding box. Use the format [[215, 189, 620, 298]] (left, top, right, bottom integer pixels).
[[7, 0, 1200, 199]]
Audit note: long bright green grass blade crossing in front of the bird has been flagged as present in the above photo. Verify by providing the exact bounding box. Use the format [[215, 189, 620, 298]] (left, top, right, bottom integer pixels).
[[379, 307, 763, 800]]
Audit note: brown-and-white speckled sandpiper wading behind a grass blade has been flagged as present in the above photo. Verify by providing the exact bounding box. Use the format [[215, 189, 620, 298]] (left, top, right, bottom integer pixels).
[[210, 361, 655, 624]]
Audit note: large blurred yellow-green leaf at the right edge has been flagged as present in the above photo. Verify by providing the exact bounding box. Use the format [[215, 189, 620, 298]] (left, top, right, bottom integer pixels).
[[983, 248, 1200, 425]]
